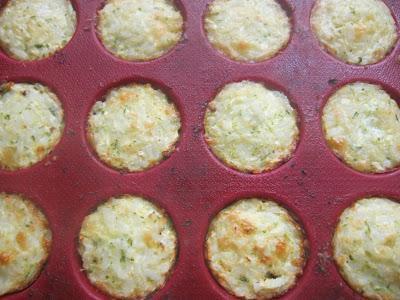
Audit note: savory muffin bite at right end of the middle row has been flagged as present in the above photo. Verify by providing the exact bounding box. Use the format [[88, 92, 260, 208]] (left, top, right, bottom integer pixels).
[[322, 82, 400, 173]]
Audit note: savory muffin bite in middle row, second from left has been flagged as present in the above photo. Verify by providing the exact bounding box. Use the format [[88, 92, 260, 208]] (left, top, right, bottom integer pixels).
[[88, 84, 181, 172]]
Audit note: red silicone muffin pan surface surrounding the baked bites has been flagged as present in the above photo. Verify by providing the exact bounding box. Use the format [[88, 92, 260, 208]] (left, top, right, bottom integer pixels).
[[0, 0, 400, 300]]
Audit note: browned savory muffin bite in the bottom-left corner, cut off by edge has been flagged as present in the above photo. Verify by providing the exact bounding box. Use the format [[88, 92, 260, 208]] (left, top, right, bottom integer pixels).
[[0, 193, 51, 296]]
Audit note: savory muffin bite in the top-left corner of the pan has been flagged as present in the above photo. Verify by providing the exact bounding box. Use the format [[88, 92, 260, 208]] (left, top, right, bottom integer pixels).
[[0, 0, 76, 60]]
